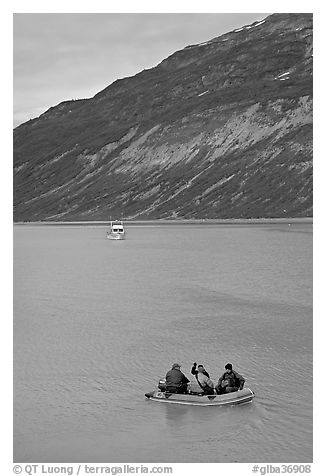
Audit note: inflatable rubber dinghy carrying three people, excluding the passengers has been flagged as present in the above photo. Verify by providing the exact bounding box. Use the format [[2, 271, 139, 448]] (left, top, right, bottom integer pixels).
[[145, 385, 255, 407]]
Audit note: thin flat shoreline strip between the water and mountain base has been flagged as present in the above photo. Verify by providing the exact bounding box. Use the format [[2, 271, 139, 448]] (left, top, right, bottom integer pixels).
[[13, 217, 313, 226]]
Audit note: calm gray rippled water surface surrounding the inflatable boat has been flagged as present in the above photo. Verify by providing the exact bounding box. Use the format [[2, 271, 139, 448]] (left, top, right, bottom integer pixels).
[[14, 223, 313, 463]]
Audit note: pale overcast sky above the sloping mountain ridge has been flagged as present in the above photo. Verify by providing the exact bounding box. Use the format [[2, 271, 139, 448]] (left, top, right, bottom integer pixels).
[[13, 13, 268, 127]]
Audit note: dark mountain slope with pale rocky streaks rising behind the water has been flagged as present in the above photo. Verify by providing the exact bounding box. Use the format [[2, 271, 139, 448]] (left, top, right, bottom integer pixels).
[[14, 14, 312, 221]]
